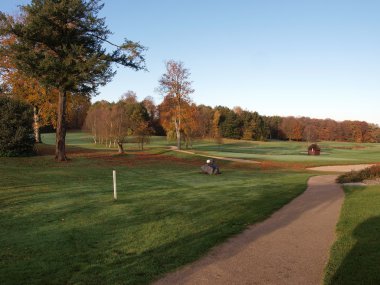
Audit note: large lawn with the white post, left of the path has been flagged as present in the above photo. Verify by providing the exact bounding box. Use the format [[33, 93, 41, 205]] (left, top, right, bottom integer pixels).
[[0, 133, 310, 284]]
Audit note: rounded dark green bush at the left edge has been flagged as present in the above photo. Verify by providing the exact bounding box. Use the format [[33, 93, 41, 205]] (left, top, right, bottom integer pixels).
[[0, 96, 34, 156]]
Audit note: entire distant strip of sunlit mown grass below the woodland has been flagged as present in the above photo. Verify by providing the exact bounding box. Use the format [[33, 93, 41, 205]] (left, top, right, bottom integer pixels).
[[43, 132, 380, 166]]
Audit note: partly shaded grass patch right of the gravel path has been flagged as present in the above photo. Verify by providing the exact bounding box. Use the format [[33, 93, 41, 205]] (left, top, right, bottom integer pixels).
[[324, 185, 380, 285]]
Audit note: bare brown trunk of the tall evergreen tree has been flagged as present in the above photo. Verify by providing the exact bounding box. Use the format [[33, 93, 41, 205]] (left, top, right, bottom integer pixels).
[[55, 90, 67, 161]]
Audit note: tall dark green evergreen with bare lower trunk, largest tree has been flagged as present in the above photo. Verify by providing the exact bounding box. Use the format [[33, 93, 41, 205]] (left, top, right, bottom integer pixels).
[[0, 0, 144, 161]]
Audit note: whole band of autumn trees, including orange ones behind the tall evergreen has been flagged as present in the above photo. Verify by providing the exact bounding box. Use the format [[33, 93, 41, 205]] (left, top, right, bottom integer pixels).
[[0, 66, 380, 144]]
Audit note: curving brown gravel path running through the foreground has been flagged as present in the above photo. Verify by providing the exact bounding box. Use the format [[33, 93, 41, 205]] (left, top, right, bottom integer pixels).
[[154, 165, 367, 285]]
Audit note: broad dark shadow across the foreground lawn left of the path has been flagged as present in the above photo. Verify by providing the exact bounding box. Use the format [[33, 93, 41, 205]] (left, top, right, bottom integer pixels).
[[0, 178, 314, 284]]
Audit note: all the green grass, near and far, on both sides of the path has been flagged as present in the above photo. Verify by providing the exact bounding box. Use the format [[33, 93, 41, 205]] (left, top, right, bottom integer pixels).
[[0, 132, 380, 284]]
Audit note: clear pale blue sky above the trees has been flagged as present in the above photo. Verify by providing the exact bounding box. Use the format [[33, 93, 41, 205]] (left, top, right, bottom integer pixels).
[[0, 0, 380, 124]]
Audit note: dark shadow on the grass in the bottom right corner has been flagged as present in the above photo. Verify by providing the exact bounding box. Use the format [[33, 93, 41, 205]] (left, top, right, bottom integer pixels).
[[329, 216, 380, 285]]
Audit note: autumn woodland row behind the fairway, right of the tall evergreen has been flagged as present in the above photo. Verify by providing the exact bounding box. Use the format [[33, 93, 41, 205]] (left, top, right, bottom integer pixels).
[[82, 92, 380, 147]]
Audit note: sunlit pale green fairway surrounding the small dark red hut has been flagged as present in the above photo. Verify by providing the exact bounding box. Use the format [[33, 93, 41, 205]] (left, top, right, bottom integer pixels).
[[194, 140, 380, 166]]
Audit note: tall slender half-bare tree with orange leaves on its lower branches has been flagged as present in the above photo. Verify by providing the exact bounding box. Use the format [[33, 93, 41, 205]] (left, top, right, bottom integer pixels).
[[158, 60, 194, 149]]
